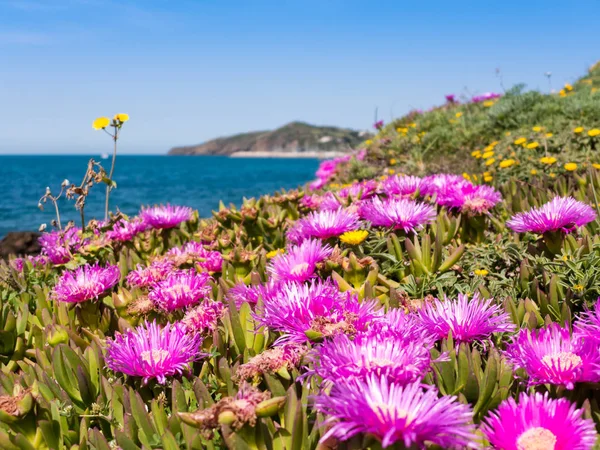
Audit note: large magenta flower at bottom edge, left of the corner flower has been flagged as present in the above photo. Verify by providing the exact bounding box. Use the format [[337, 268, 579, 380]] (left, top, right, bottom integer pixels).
[[314, 376, 479, 448]]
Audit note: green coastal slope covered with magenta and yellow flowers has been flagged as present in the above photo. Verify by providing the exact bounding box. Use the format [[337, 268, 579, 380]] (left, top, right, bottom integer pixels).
[[0, 63, 600, 450]]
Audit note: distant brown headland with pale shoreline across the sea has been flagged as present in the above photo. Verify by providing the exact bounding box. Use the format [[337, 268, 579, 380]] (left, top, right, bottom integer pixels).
[[169, 122, 370, 158]]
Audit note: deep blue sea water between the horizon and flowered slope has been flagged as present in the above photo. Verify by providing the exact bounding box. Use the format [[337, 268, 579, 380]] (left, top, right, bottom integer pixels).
[[0, 155, 319, 237]]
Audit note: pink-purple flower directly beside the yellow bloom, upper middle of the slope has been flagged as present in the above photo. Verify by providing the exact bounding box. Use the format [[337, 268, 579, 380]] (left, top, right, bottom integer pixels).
[[287, 208, 360, 244]]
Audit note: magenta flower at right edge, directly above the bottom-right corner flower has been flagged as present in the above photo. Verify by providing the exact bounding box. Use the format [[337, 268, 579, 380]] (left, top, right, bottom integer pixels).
[[506, 323, 600, 389]]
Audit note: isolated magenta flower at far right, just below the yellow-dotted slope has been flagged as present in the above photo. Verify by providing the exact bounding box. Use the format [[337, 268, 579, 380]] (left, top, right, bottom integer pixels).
[[506, 197, 596, 234]]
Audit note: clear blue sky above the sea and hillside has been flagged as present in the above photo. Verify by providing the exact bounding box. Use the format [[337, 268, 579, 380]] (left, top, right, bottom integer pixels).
[[0, 0, 600, 154]]
